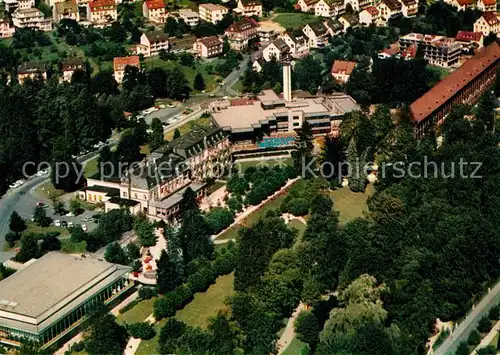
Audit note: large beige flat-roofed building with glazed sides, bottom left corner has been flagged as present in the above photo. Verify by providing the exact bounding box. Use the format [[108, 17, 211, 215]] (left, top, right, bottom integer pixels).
[[0, 252, 133, 348]]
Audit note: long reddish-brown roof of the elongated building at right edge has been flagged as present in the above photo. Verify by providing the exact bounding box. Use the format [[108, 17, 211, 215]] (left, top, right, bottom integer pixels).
[[410, 43, 500, 122]]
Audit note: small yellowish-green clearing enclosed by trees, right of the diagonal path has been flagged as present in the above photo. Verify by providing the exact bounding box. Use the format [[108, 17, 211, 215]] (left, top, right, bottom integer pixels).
[[330, 184, 375, 223]]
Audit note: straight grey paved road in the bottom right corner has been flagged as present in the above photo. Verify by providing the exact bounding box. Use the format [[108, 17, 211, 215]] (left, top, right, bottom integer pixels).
[[434, 282, 500, 355]]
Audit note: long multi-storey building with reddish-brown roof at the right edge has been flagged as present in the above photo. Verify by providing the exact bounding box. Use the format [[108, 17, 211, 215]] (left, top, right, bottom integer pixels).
[[410, 43, 500, 138]]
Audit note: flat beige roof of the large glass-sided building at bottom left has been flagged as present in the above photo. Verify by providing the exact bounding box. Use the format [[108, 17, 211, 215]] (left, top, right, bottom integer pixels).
[[0, 252, 130, 333]]
